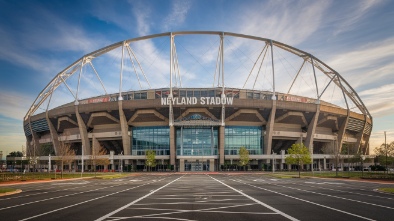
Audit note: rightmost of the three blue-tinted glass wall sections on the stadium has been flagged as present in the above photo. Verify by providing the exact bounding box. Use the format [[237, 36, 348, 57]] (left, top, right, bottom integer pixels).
[[224, 126, 263, 155]]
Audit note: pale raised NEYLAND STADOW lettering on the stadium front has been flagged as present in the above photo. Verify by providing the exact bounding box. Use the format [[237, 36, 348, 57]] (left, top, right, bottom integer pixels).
[[161, 97, 234, 105]]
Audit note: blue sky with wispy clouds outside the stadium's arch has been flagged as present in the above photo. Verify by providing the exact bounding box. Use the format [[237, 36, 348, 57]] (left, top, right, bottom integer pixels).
[[0, 0, 394, 159]]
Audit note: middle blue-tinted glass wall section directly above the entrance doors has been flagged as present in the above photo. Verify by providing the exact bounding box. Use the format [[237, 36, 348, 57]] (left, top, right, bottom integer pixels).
[[176, 127, 218, 156]]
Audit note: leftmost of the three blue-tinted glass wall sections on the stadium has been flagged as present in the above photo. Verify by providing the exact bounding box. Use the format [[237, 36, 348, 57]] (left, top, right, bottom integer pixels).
[[132, 127, 170, 155]]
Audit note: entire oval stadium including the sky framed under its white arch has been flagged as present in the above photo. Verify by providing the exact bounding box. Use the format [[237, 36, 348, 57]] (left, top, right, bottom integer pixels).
[[23, 31, 372, 172]]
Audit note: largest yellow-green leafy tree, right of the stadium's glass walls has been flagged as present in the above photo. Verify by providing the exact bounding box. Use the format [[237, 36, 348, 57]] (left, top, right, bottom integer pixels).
[[285, 144, 312, 177]]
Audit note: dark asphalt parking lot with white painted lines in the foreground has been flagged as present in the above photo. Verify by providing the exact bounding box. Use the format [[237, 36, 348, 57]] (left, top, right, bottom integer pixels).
[[0, 173, 394, 221]]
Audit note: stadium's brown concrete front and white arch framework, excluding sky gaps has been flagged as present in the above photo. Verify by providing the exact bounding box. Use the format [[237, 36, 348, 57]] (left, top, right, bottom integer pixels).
[[23, 31, 372, 171]]
